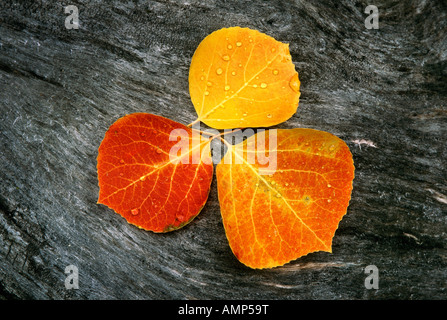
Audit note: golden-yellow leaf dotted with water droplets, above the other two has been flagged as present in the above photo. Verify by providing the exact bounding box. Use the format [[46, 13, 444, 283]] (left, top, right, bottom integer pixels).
[[189, 27, 300, 129]]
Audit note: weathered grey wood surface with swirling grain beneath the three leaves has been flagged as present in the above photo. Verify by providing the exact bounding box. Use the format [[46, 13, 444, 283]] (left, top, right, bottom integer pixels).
[[0, 0, 447, 299]]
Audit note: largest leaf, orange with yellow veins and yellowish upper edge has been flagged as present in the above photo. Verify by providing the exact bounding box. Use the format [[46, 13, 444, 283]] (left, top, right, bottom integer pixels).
[[216, 129, 354, 268]]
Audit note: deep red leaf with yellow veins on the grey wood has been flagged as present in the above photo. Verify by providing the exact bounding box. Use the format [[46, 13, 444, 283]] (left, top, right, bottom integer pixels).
[[97, 113, 213, 232]]
